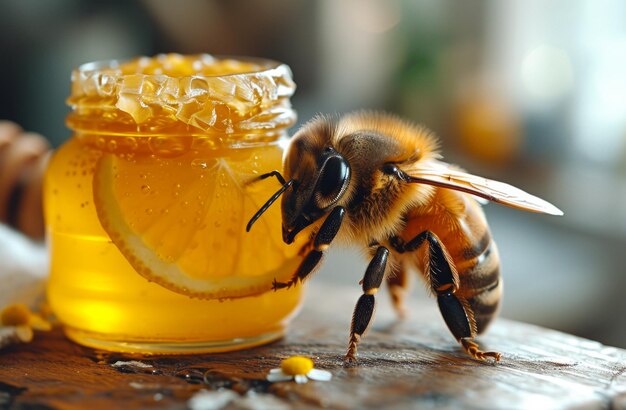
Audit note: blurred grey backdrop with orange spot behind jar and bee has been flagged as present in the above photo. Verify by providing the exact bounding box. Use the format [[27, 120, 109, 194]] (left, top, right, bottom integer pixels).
[[0, 0, 626, 348]]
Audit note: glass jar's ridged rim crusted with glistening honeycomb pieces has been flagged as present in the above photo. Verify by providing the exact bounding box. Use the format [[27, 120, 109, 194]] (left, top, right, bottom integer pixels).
[[67, 53, 296, 135]]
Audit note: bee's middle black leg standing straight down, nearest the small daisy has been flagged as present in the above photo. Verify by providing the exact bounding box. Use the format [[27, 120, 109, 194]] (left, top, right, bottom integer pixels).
[[344, 246, 389, 363]]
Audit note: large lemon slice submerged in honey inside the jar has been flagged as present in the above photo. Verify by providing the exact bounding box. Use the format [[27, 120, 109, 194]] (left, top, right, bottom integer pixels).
[[93, 149, 297, 299]]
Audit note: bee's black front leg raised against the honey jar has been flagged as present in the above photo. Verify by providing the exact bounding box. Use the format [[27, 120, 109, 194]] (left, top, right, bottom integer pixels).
[[272, 206, 346, 290]]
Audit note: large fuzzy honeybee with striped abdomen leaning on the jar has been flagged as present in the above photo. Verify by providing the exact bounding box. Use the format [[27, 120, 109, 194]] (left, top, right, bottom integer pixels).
[[247, 112, 563, 362]]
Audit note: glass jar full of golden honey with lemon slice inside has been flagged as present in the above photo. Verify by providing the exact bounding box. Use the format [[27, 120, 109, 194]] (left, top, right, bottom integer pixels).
[[45, 54, 302, 353]]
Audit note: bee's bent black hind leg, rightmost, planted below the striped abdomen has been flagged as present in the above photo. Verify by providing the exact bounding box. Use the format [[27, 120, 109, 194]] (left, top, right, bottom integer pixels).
[[404, 231, 500, 361]]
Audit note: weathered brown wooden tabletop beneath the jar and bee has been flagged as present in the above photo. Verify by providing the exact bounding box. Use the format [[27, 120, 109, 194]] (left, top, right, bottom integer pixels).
[[0, 281, 626, 410]]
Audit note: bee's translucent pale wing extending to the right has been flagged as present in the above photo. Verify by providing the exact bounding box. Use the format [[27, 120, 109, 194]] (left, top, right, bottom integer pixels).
[[409, 161, 563, 215]]
